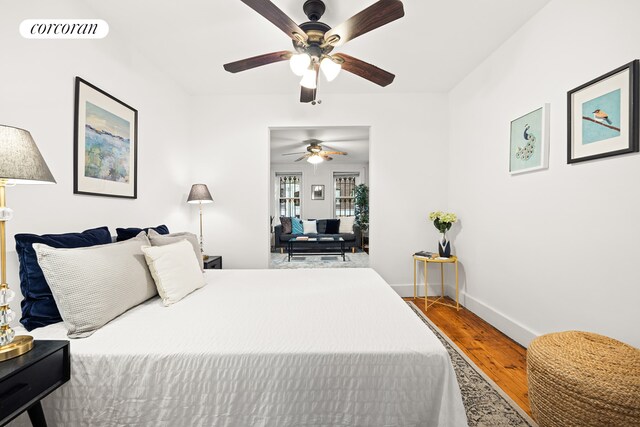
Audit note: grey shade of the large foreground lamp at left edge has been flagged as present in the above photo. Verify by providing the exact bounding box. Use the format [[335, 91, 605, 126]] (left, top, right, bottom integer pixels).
[[0, 125, 56, 184]]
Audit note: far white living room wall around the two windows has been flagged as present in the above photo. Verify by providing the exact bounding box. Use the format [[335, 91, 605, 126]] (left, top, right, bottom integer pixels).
[[269, 158, 369, 219]]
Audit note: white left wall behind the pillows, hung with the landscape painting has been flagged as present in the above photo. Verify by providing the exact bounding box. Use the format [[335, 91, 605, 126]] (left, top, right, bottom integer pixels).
[[0, 0, 192, 309]]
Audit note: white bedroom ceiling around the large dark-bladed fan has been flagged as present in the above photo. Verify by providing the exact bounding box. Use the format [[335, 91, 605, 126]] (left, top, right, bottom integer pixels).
[[87, 0, 550, 95]]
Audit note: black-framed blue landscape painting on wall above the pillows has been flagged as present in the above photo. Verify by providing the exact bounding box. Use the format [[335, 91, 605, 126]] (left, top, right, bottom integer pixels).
[[73, 77, 138, 199]]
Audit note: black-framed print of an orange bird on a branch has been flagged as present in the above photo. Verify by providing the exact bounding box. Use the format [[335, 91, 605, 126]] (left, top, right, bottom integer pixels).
[[567, 59, 640, 163]]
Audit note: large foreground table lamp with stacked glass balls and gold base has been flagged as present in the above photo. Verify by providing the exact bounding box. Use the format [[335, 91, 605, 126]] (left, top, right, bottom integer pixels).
[[0, 125, 56, 362]]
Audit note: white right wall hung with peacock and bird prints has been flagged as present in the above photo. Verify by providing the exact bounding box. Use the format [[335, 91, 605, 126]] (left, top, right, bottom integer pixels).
[[449, 0, 640, 346]]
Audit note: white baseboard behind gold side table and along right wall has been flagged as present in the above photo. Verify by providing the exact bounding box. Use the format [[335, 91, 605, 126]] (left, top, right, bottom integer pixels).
[[391, 284, 540, 347]]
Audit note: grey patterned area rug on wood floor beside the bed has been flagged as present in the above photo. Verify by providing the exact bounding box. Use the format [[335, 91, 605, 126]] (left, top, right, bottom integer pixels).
[[407, 301, 537, 427]]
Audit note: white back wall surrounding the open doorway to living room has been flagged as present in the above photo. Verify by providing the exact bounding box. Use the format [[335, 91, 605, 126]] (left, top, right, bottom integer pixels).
[[192, 93, 447, 285]]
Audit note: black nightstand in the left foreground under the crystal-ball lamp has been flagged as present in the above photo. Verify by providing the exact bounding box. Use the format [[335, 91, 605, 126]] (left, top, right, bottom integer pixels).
[[0, 341, 71, 427]]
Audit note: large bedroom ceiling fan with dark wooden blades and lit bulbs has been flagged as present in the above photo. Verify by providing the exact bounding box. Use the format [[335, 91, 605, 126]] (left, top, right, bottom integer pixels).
[[224, 0, 404, 105]]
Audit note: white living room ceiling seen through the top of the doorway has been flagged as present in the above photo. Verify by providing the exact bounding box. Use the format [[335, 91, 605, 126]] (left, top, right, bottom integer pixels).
[[270, 126, 369, 164]]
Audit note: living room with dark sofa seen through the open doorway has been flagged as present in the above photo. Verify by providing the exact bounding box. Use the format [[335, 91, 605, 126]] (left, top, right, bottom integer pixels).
[[269, 126, 370, 268]]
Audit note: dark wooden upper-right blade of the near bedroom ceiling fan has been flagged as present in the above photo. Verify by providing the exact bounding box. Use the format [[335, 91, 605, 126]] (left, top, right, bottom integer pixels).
[[324, 0, 404, 47]]
